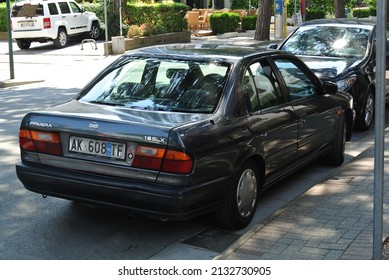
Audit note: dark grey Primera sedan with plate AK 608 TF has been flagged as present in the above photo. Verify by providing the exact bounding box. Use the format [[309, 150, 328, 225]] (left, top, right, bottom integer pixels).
[[16, 45, 353, 229]]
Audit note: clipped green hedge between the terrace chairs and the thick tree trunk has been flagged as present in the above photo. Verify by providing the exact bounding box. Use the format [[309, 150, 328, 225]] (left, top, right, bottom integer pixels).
[[209, 12, 240, 34]]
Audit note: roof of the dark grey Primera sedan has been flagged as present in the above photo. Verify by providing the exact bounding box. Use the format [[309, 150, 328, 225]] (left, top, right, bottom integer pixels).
[[121, 43, 282, 62]]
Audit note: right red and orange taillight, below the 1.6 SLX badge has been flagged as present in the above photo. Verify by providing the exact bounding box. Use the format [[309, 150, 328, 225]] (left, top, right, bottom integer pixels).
[[132, 146, 193, 174]]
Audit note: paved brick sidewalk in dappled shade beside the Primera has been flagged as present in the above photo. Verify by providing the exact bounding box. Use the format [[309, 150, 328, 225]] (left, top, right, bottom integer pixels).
[[215, 131, 389, 260]]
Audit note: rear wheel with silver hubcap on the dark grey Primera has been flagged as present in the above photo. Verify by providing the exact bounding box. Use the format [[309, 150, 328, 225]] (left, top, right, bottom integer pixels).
[[215, 161, 259, 230]]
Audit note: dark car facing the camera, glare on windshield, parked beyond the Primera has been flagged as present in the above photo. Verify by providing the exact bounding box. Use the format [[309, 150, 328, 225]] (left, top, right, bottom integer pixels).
[[271, 18, 389, 130]]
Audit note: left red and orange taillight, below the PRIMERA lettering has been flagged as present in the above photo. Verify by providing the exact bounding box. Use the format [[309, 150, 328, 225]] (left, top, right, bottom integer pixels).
[[19, 129, 62, 155]]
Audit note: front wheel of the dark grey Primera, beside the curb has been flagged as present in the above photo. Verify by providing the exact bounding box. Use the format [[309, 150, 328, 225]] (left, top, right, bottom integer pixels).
[[327, 115, 347, 166]]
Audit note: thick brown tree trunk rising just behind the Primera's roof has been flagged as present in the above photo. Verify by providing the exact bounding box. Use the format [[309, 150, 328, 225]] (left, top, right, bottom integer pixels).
[[254, 0, 274, 41]]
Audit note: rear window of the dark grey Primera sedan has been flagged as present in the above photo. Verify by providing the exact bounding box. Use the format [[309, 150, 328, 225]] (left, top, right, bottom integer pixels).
[[80, 58, 229, 113]]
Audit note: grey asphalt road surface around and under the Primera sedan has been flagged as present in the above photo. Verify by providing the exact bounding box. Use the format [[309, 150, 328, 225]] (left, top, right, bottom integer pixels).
[[0, 38, 382, 260]]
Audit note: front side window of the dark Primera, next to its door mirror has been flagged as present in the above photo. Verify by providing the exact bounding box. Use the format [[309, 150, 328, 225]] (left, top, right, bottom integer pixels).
[[274, 59, 317, 100]]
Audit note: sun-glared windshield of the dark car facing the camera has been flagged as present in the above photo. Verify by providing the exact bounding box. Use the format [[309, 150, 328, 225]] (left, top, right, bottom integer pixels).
[[282, 25, 372, 59]]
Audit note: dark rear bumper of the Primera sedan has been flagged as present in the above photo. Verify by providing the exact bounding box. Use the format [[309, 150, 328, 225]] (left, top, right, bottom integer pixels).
[[16, 163, 232, 220]]
